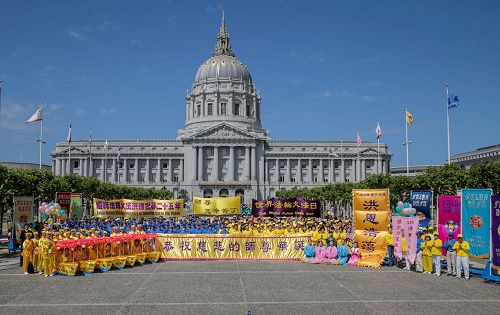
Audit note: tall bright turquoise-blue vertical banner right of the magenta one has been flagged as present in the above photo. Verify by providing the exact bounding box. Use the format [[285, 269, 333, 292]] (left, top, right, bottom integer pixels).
[[462, 189, 491, 258]]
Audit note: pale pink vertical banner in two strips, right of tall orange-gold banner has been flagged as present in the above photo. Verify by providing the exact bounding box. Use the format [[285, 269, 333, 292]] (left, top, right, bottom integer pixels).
[[392, 216, 419, 264]]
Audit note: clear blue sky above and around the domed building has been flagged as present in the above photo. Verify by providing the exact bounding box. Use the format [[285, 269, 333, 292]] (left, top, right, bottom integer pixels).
[[0, 0, 500, 165]]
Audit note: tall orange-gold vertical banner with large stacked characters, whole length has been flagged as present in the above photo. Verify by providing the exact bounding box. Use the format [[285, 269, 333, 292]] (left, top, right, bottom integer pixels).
[[352, 189, 389, 268]]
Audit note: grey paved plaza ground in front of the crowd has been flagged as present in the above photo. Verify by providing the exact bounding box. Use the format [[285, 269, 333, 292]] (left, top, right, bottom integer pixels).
[[0, 261, 500, 315]]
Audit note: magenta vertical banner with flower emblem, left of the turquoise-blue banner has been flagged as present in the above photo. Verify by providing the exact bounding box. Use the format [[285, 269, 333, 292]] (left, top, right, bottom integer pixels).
[[438, 196, 462, 254]]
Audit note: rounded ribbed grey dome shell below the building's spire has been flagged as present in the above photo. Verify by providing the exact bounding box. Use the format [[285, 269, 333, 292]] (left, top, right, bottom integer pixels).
[[195, 55, 252, 84]]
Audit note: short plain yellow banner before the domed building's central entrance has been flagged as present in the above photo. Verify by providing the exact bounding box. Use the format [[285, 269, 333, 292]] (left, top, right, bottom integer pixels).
[[193, 196, 241, 215]]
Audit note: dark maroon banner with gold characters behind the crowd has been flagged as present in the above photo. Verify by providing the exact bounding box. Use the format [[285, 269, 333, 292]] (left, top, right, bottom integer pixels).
[[252, 197, 321, 217]]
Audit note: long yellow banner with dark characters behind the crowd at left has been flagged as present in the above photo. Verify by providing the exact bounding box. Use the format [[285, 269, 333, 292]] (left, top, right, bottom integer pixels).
[[93, 198, 185, 218]]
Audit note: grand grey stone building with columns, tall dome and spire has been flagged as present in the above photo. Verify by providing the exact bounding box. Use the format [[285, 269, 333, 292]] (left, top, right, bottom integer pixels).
[[52, 17, 391, 203]]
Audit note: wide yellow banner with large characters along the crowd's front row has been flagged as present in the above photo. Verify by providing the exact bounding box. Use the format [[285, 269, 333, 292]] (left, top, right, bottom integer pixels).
[[158, 234, 309, 260]]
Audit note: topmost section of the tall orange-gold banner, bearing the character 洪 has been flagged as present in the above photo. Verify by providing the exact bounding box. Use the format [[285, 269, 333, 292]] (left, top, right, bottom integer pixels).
[[352, 189, 389, 211]]
